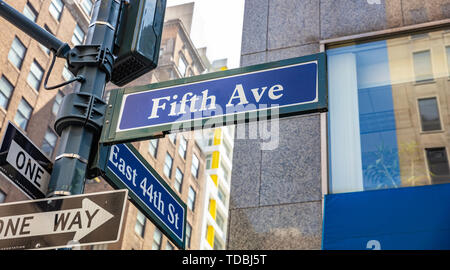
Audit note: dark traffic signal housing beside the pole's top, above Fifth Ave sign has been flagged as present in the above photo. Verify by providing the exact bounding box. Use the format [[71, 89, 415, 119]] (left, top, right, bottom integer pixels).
[[111, 0, 166, 86]]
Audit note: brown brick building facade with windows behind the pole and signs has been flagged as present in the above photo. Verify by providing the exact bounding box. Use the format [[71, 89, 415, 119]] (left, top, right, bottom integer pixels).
[[0, 0, 211, 249]]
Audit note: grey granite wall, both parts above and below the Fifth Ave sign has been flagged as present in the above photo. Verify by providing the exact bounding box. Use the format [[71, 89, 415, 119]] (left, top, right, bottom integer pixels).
[[227, 0, 450, 249]]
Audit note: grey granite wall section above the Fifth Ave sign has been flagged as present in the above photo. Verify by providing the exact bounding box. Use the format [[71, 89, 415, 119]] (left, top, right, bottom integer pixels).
[[241, 0, 450, 62]]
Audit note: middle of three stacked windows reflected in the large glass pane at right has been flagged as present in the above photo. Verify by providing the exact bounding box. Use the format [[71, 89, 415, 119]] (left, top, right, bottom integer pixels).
[[418, 97, 441, 131]]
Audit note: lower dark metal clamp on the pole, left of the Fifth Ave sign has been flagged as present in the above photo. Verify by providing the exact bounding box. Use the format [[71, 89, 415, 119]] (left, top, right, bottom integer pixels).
[[54, 92, 107, 136]]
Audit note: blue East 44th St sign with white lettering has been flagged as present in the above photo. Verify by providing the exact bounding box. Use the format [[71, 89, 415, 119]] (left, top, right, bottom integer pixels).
[[105, 144, 186, 249]]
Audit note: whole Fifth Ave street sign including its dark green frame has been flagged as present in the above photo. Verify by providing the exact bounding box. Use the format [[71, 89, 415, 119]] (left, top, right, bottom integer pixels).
[[101, 54, 327, 143]]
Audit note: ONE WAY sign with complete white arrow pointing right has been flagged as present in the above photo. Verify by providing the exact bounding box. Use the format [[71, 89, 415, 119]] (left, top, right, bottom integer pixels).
[[0, 190, 127, 250]]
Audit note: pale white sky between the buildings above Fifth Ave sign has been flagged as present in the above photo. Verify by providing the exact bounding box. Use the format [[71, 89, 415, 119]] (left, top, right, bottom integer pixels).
[[167, 0, 244, 69]]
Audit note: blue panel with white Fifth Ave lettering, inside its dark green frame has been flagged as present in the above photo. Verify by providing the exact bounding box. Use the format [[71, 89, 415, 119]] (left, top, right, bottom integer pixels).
[[118, 62, 318, 131]]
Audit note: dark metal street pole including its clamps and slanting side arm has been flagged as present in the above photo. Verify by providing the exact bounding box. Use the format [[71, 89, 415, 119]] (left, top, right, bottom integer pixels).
[[0, 0, 122, 197]]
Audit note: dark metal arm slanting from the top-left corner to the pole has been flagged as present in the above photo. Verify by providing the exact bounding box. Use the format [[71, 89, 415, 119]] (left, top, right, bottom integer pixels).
[[0, 0, 70, 57]]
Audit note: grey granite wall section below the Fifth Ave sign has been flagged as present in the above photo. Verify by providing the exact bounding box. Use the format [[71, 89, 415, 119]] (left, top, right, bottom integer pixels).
[[227, 114, 322, 249]]
